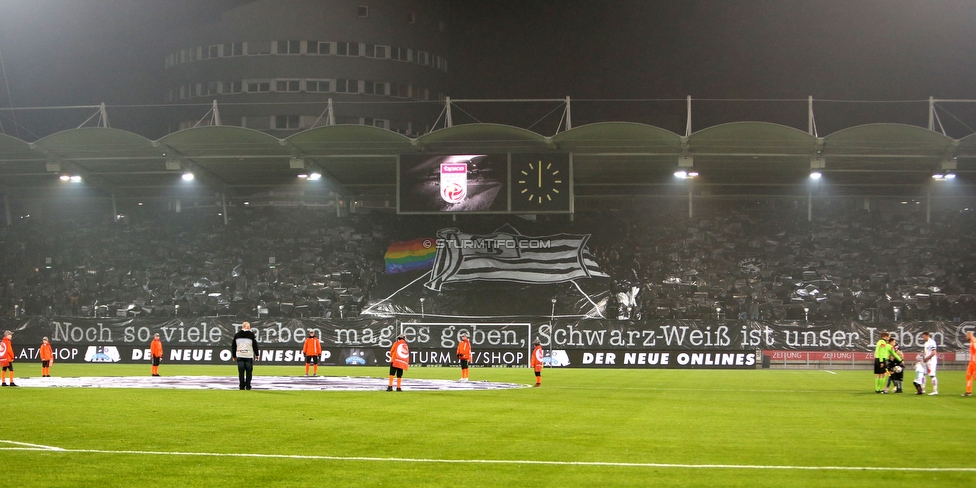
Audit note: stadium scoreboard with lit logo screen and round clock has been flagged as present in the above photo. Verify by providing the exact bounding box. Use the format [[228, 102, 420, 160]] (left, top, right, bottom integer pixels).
[[396, 153, 573, 214]]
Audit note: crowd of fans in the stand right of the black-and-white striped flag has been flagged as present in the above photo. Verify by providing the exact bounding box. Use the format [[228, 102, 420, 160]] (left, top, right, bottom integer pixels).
[[593, 200, 976, 322]]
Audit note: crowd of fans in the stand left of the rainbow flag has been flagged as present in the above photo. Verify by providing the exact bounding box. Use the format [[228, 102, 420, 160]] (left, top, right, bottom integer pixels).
[[0, 208, 385, 317]]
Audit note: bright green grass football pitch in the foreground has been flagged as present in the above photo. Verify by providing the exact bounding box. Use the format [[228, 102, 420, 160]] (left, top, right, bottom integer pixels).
[[0, 363, 976, 488]]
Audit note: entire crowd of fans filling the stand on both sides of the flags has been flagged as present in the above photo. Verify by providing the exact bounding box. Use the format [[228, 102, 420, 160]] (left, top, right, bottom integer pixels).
[[0, 199, 976, 322]]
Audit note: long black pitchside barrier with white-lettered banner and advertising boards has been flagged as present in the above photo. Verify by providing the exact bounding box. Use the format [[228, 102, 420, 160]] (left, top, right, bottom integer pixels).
[[0, 317, 976, 369]]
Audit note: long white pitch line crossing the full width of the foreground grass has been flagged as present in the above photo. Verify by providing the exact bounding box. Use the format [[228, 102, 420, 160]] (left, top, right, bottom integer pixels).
[[0, 441, 976, 473]]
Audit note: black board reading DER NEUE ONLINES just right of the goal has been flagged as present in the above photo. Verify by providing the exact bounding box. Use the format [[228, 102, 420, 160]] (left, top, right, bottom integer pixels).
[[544, 349, 757, 369]]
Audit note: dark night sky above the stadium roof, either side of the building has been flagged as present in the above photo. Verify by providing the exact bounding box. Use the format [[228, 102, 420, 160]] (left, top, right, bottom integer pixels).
[[0, 0, 976, 139]]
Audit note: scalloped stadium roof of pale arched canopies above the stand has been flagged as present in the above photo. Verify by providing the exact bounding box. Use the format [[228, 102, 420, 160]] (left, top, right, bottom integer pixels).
[[0, 122, 976, 199]]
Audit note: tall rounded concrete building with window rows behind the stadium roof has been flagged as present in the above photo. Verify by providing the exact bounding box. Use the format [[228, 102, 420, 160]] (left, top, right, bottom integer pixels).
[[160, 0, 448, 137]]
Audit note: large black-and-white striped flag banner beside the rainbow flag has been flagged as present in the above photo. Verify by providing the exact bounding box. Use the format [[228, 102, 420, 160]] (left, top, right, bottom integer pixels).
[[424, 226, 609, 291]]
